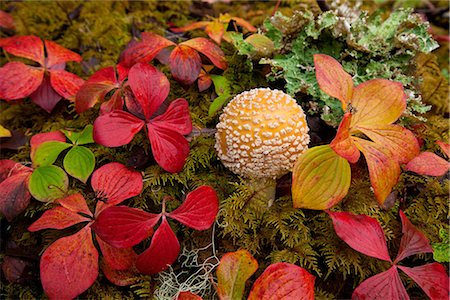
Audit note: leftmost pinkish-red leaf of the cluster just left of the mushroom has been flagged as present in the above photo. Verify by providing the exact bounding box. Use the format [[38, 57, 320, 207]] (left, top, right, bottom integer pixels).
[[93, 110, 145, 147]]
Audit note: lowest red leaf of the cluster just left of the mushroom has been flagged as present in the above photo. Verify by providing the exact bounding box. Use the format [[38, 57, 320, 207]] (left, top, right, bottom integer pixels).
[[147, 123, 189, 173]]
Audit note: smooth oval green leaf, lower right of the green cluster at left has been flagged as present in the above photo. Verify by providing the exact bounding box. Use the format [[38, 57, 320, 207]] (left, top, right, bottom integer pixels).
[[63, 146, 95, 183]]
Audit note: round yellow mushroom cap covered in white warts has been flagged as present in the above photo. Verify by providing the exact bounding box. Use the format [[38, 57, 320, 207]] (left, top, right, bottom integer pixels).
[[215, 88, 309, 178]]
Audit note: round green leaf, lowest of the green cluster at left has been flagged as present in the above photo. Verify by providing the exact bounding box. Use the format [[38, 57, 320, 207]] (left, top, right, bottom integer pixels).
[[28, 166, 69, 202]]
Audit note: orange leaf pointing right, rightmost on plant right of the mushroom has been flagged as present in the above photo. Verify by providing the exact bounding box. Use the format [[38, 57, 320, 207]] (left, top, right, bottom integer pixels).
[[358, 125, 420, 164]]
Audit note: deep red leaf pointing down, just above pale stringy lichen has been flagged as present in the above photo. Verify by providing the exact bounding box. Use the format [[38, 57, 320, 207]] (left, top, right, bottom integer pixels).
[[136, 216, 180, 275]]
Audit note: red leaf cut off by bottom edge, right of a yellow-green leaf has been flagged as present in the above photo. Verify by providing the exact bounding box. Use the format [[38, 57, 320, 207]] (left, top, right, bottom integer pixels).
[[248, 263, 315, 300]]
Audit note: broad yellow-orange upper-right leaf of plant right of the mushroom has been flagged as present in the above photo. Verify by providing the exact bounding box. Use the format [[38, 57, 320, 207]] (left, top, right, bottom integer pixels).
[[350, 79, 406, 128]]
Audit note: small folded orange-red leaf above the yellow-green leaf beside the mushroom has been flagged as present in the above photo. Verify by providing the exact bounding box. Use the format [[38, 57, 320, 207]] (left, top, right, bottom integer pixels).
[[330, 113, 361, 164]]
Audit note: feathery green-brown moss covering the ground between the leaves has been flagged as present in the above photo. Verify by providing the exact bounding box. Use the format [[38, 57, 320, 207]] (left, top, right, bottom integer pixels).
[[0, 1, 449, 299]]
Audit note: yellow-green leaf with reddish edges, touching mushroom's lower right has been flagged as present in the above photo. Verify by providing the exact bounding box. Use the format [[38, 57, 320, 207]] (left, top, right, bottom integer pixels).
[[292, 145, 351, 209]]
